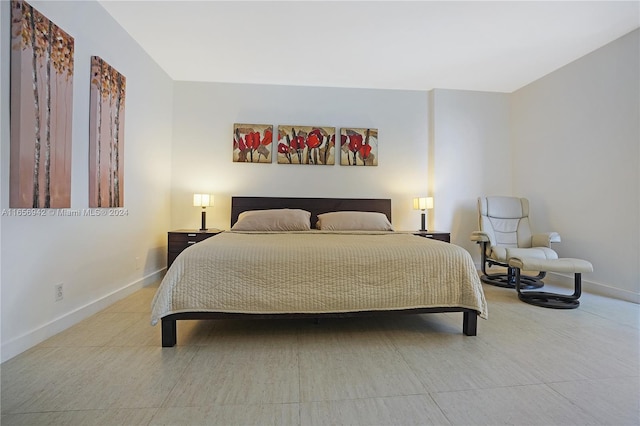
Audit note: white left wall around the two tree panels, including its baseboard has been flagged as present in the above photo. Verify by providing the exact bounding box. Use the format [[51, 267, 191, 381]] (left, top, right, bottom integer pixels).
[[0, 1, 173, 360]]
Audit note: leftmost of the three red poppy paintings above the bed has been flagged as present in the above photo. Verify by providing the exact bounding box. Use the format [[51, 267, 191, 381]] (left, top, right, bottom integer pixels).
[[233, 124, 273, 163]]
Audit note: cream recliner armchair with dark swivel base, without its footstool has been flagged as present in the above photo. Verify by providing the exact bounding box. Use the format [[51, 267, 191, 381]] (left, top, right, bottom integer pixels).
[[471, 197, 560, 288]]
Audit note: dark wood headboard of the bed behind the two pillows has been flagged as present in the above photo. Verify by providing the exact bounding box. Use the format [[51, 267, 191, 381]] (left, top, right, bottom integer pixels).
[[231, 197, 391, 228]]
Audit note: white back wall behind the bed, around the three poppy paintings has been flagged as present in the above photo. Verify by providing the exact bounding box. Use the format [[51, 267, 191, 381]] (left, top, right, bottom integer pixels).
[[171, 82, 429, 230]]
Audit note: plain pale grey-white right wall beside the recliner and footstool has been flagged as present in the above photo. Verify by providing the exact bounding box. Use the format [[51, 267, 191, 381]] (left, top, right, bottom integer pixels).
[[512, 30, 640, 303]]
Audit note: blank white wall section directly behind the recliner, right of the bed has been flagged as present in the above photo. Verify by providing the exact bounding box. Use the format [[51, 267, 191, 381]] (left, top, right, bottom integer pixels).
[[429, 89, 512, 256]]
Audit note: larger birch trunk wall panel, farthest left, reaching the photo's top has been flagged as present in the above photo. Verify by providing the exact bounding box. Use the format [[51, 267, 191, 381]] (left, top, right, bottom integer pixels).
[[9, 0, 74, 208]]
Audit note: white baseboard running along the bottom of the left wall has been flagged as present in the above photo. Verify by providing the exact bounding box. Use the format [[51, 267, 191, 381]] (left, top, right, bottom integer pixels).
[[0, 268, 166, 362]]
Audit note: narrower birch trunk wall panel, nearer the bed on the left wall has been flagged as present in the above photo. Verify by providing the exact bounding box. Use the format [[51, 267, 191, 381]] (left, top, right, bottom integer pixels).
[[89, 56, 126, 208]]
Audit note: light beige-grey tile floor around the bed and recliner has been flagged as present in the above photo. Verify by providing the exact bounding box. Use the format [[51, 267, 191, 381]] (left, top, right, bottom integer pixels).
[[0, 278, 640, 425]]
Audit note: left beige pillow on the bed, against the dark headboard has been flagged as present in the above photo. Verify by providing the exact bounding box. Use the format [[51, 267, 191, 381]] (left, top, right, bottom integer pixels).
[[231, 209, 311, 231]]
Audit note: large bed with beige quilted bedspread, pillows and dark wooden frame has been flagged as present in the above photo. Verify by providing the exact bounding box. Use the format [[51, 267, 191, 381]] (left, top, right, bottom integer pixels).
[[151, 197, 488, 347]]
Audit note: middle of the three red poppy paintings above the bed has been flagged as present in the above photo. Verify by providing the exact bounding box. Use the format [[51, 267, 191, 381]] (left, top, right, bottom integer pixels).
[[278, 125, 336, 166]]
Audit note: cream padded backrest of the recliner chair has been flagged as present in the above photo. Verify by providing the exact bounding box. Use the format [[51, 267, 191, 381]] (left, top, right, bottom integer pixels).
[[478, 197, 531, 248]]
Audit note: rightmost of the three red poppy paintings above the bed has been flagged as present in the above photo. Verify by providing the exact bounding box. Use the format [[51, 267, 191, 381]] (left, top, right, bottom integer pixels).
[[340, 128, 378, 166]]
